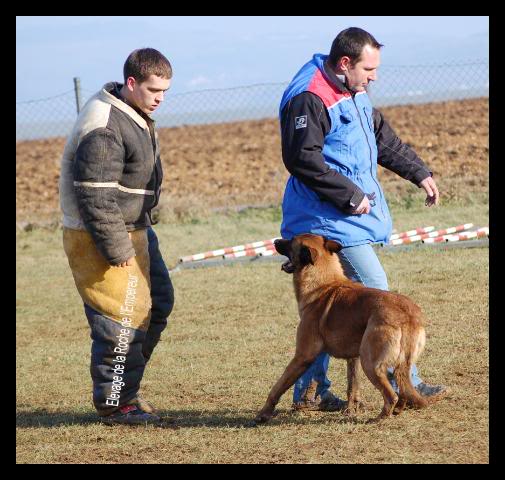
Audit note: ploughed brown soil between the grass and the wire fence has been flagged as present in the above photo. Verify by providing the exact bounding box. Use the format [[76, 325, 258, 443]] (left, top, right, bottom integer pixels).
[[16, 98, 489, 222]]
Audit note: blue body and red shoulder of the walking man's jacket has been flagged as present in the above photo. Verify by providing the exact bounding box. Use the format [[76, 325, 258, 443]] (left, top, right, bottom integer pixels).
[[280, 54, 392, 247]]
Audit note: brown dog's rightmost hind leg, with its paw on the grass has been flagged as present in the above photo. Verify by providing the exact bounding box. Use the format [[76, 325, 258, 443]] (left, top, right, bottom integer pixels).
[[394, 325, 430, 410]]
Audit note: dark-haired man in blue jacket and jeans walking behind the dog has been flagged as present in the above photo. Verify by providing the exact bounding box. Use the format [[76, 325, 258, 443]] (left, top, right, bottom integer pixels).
[[280, 27, 448, 411]]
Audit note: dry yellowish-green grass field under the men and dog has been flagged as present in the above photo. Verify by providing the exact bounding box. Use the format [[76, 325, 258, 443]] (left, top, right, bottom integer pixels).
[[16, 194, 489, 463]]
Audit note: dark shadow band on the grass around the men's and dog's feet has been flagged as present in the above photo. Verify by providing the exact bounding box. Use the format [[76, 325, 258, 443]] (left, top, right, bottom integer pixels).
[[16, 408, 366, 429]]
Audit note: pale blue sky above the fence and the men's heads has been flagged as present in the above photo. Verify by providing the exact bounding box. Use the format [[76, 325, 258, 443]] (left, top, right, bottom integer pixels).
[[16, 16, 489, 102]]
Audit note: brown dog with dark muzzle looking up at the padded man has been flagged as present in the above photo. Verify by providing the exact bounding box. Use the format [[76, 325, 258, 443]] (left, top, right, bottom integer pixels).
[[255, 234, 442, 423]]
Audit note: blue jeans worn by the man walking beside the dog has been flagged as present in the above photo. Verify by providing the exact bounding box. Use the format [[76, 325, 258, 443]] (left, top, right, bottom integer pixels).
[[293, 244, 422, 402]]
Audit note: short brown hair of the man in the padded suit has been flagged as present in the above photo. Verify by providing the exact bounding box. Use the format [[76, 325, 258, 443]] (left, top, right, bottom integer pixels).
[[123, 48, 172, 83]]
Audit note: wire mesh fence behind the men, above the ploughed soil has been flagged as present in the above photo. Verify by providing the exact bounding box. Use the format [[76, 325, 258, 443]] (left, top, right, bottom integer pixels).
[[16, 60, 489, 141]]
